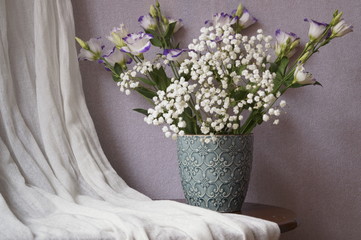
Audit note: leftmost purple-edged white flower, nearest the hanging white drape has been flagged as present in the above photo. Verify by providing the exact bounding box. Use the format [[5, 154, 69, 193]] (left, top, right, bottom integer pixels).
[[78, 38, 104, 61]]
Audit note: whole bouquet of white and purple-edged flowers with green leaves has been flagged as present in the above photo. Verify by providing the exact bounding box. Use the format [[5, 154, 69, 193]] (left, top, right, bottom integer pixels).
[[76, 1, 352, 138]]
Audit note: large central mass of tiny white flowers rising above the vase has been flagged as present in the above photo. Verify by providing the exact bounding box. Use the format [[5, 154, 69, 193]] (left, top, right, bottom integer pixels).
[[145, 25, 286, 138]]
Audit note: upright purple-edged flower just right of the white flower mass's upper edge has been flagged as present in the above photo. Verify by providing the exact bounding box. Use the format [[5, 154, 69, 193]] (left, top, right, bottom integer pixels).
[[275, 29, 300, 58]]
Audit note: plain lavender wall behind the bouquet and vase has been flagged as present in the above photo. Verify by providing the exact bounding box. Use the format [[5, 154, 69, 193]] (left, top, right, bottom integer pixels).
[[73, 0, 361, 240]]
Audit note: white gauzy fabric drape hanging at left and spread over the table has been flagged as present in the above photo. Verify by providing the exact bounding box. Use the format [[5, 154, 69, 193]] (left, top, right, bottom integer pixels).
[[0, 0, 279, 240]]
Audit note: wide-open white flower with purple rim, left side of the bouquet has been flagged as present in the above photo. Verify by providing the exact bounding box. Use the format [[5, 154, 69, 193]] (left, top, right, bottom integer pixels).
[[121, 32, 153, 55]]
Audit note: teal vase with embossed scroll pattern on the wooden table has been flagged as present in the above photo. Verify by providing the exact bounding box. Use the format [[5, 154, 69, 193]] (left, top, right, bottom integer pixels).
[[177, 134, 253, 212]]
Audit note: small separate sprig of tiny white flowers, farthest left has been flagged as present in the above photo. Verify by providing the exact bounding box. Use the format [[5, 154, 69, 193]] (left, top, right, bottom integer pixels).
[[117, 61, 161, 95]]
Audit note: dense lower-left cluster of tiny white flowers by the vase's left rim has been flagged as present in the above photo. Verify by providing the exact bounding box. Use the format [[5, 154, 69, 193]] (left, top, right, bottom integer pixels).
[[144, 77, 196, 139]]
